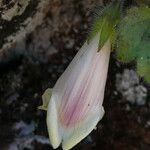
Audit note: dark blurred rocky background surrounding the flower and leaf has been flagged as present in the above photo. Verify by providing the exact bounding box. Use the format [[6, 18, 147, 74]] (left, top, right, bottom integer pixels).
[[0, 0, 150, 150]]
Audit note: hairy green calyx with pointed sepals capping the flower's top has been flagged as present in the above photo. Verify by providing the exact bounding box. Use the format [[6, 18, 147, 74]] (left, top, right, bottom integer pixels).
[[88, 0, 120, 49]]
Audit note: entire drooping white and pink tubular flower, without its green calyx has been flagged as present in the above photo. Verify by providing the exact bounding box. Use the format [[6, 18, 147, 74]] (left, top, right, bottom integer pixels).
[[40, 34, 111, 150]]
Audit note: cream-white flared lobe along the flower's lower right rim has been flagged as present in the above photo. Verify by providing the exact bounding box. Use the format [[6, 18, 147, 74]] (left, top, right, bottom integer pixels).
[[62, 107, 104, 150]]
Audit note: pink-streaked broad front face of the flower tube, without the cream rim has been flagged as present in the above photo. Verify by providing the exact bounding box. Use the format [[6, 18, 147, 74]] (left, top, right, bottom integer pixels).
[[58, 39, 110, 127]]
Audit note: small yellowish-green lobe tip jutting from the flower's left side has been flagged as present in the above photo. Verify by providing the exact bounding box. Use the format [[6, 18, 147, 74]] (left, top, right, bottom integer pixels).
[[38, 88, 52, 111]]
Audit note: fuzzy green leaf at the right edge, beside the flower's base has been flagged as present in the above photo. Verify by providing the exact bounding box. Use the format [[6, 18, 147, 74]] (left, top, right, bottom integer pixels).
[[116, 7, 150, 81]]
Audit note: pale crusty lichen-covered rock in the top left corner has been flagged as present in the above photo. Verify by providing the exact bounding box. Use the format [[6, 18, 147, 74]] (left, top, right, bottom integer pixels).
[[0, 0, 50, 54]]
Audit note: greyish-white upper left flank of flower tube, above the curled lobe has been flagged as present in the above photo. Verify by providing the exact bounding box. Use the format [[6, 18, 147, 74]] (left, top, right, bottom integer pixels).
[[53, 34, 99, 108]]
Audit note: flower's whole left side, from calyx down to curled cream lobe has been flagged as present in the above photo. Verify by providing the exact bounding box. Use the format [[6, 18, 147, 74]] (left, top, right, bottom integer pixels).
[[47, 35, 99, 148]]
